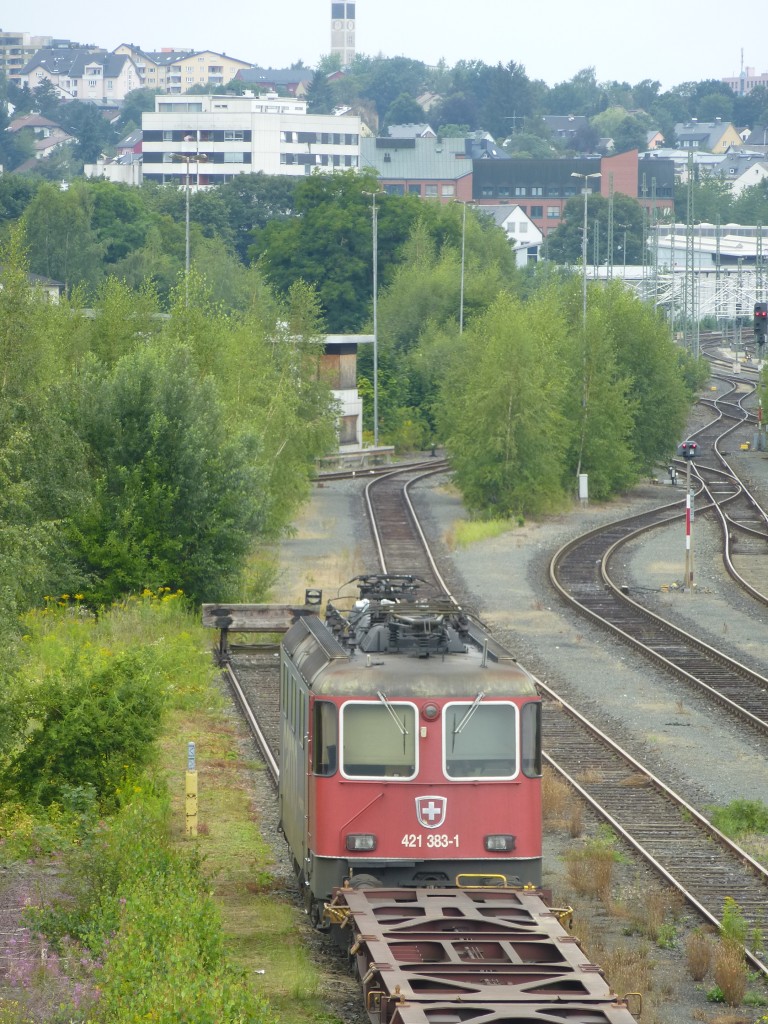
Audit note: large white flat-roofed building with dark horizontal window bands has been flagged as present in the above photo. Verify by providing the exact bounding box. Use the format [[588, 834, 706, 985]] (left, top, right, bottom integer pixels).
[[141, 93, 360, 187]]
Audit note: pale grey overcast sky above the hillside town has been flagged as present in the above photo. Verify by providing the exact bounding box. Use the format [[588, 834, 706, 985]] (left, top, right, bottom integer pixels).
[[20, 0, 768, 89]]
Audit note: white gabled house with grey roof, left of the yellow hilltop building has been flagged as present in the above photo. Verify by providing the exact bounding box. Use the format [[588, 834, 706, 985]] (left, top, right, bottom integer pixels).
[[19, 48, 141, 103]]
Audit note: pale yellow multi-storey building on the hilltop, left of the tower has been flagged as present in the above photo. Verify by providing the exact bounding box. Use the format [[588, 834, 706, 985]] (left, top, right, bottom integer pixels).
[[115, 43, 253, 94]]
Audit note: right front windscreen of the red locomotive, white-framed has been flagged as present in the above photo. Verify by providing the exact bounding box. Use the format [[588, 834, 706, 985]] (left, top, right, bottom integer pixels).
[[443, 694, 517, 778]]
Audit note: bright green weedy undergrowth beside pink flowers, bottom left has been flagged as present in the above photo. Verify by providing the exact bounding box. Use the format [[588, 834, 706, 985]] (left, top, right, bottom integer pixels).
[[27, 777, 274, 1024]]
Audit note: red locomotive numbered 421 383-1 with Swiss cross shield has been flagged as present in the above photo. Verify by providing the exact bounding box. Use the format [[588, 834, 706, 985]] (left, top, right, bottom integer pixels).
[[280, 574, 542, 922]]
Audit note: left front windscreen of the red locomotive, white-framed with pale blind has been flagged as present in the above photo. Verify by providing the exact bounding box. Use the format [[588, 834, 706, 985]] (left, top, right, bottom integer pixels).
[[341, 697, 417, 778]]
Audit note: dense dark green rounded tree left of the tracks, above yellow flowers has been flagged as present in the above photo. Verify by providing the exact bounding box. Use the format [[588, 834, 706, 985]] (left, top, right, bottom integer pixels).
[[69, 343, 263, 605]]
